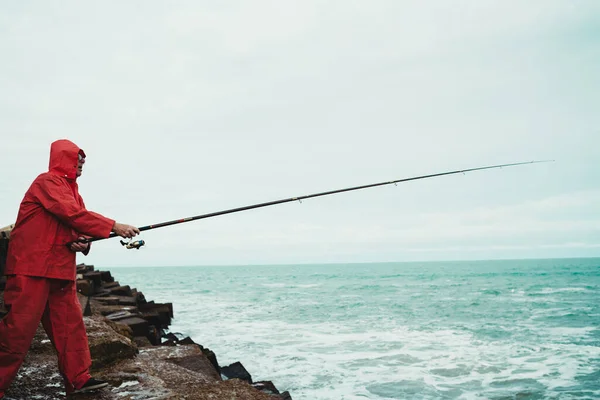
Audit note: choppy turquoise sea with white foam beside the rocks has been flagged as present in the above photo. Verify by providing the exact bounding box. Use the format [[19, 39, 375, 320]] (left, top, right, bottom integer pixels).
[[110, 258, 600, 400]]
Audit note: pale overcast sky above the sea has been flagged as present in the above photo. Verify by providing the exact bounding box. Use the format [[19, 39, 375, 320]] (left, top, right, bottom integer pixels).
[[0, 0, 600, 267]]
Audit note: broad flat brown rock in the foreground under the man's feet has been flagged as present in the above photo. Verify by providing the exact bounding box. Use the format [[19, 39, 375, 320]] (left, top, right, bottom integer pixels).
[[6, 345, 276, 400]]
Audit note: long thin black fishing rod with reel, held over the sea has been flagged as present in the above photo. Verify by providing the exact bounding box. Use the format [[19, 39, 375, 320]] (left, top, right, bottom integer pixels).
[[72, 160, 554, 250]]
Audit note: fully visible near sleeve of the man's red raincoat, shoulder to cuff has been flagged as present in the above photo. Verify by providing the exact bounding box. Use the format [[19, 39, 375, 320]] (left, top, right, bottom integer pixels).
[[31, 174, 115, 238]]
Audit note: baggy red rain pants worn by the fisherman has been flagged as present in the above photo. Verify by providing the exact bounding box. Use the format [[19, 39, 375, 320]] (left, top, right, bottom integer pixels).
[[0, 275, 92, 398]]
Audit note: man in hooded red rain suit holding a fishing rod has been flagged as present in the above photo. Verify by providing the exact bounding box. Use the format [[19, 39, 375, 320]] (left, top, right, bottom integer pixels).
[[0, 140, 140, 398]]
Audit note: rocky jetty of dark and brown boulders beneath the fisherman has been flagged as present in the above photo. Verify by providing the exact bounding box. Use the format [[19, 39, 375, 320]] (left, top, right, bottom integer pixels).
[[0, 264, 292, 400]]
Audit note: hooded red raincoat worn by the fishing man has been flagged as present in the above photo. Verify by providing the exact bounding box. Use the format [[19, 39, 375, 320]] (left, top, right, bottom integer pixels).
[[5, 140, 115, 280]]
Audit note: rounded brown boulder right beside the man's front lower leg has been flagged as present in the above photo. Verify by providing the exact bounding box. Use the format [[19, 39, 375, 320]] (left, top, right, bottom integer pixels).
[[84, 316, 138, 369]]
